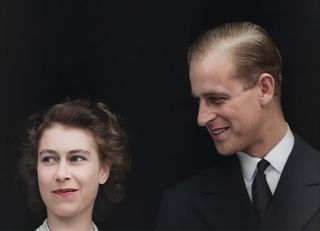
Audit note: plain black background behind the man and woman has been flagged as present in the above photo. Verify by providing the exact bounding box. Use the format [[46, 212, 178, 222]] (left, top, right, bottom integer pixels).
[[0, 0, 320, 230]]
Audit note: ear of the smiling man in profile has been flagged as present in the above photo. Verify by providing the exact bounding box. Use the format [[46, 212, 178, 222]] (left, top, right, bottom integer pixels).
[[258, 73, 275, 106]]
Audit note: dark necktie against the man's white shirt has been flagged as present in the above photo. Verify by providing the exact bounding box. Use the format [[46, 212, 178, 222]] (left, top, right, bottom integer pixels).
[[252, 159, 272, 221]]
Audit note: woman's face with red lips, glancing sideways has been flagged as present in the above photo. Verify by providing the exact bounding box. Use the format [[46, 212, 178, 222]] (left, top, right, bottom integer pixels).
[[37, 123, 110, 217]]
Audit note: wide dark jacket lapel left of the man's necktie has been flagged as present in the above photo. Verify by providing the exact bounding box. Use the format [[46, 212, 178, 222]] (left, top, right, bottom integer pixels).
[[193, 155, 257, 230]]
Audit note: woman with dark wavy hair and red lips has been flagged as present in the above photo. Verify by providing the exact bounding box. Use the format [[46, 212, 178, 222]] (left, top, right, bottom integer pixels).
[[20, 100, 129, 231]]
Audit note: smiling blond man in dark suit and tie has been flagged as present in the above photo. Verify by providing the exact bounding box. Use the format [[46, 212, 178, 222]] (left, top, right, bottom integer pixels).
[[158, 22, 320, 230]]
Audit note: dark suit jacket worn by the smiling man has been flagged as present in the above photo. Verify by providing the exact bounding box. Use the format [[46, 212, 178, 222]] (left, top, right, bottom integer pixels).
[[157, 136, 320, 230]]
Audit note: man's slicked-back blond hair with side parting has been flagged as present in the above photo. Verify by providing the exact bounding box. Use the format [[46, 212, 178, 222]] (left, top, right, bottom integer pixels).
[[188, 22, 282, 96]]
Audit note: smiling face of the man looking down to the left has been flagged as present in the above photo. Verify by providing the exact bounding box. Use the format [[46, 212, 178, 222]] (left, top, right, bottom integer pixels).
[[189, 52, 263, 155]]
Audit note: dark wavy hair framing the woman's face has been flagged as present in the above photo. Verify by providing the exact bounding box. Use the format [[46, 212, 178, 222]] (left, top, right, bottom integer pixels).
[[19, 100, 130, 220]]
